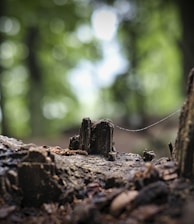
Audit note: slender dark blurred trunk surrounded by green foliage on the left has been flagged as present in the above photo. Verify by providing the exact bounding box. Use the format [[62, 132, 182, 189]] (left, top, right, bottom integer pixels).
[[26, 26, 44, 136]]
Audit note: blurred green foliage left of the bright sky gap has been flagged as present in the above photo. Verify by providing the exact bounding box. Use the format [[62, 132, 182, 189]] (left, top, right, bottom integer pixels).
[[0, 0, 100, 136]]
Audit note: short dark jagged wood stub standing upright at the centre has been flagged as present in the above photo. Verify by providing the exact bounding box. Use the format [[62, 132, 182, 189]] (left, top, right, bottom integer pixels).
[[69, 118, 114, 159]]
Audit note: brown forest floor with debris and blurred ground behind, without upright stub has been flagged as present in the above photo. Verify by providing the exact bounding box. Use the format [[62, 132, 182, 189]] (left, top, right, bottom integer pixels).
[[0, 116, 194, 224]]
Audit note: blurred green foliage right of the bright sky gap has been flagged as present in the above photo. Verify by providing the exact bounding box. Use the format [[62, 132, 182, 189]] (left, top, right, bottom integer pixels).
[[99, 0, 185, 126]]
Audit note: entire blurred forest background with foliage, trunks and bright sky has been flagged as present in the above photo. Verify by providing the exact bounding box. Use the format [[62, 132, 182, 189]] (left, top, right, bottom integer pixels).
[[0, 0, 194, 152]]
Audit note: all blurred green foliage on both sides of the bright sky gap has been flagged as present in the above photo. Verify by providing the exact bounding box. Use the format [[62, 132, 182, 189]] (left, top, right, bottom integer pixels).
[[0, 0, 191, 137]]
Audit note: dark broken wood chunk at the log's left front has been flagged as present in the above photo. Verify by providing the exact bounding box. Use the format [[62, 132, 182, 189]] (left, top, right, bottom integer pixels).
[[18, 147, 62, 206]]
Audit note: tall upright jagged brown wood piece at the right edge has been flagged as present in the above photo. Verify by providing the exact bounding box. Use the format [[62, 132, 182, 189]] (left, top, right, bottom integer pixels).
[[175, 68, 194, 178]]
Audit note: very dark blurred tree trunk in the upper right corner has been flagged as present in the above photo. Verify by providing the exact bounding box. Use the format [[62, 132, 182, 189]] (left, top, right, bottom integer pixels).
[[178, 0, 194, 91]]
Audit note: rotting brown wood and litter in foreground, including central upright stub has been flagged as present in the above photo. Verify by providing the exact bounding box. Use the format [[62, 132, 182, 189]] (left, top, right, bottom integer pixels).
[[0, 118, 194, 224]]
